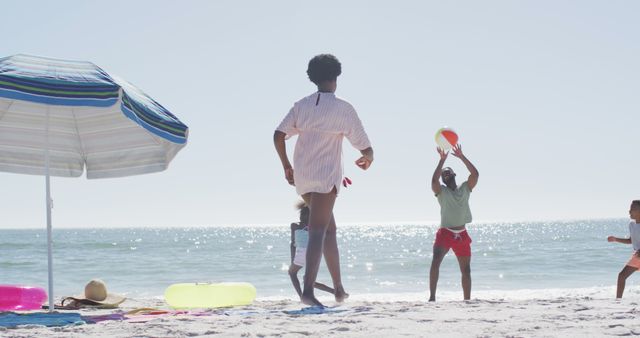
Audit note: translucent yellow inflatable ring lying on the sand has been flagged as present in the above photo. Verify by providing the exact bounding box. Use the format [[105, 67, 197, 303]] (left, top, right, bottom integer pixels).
[[164, 283, 256, 309]]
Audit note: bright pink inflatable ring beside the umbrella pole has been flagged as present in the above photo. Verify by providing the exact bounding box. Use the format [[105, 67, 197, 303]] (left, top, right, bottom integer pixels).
[[0, 285, 47, 311]]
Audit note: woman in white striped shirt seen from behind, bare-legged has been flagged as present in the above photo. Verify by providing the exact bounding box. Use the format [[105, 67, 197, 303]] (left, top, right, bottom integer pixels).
[[273, 54, 373, 306]]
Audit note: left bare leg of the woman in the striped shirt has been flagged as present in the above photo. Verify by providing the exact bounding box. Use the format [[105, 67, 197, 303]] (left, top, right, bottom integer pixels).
[[300, 189, 336, 306]]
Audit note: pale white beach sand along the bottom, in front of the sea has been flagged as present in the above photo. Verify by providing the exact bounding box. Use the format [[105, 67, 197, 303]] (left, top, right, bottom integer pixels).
[[0, 289, 640, 337]]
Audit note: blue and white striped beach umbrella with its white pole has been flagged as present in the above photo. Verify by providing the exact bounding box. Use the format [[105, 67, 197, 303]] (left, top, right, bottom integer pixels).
[[0, 55, 188, 311]]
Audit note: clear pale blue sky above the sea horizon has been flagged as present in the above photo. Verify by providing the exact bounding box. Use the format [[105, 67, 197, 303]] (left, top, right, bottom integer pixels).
[[0, 0, 640, 228]]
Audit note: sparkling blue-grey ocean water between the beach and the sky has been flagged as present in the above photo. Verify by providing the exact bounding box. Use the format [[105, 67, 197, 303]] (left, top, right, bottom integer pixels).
[[0, 219, 640, 299]]
